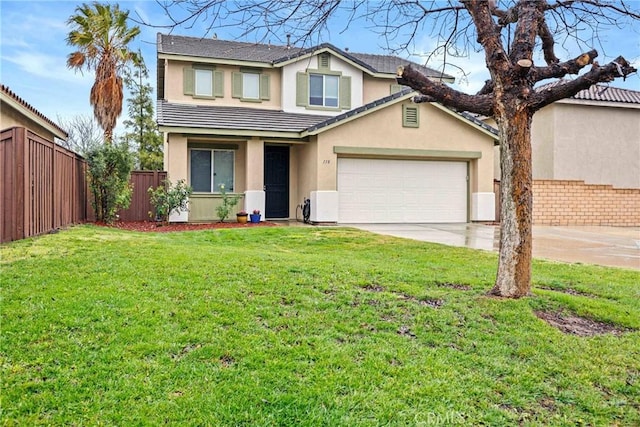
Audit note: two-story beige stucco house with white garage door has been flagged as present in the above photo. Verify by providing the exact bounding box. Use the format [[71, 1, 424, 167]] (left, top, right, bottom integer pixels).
[[157, 34, 497, 223]]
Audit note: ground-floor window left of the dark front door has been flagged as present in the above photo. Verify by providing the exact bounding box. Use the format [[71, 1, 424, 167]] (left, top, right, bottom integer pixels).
[[189, 149, 235, 193]]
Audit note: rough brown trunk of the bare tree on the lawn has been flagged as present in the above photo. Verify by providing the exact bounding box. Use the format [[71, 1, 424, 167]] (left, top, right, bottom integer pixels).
[[490, 101, 533, 298]]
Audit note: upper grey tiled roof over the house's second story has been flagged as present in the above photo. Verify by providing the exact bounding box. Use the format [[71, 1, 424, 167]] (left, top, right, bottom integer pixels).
[[157, 33, 454, 81]]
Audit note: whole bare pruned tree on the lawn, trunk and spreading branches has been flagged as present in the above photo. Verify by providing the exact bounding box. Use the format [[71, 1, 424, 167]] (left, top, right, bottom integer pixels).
[[149, 0, 640, 298]]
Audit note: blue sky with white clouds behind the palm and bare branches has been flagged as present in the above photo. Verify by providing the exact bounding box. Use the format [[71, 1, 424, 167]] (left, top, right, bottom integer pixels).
[[0, 0, 640, 137]]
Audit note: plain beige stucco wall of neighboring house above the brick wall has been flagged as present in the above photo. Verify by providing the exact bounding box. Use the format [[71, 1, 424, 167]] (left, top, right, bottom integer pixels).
[[532, 103, 640, 188]]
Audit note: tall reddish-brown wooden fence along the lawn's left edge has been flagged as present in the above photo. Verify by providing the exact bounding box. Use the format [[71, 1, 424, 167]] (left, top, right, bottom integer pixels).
[[0, 127, 87, 242]]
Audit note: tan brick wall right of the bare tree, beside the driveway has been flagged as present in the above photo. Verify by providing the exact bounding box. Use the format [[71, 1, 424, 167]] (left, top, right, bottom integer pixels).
[[533, 180, 640, 227]]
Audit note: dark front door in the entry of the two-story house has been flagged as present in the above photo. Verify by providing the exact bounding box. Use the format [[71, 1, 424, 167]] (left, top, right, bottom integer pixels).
[[264, 145, 289, 218]]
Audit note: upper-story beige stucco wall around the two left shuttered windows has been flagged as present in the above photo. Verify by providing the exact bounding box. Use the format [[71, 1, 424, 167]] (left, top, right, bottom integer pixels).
[[164, 61, 282, 110]]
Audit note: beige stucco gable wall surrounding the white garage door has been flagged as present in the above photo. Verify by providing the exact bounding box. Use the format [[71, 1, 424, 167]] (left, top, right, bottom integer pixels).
[[316, 103, 493, 192]]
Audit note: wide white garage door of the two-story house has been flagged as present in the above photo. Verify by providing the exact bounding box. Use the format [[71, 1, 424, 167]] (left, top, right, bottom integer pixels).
[[338, 159, 468, 223]]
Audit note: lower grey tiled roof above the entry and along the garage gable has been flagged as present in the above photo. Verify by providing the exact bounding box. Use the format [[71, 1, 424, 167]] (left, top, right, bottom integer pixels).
[[157, 88, 498, 138]]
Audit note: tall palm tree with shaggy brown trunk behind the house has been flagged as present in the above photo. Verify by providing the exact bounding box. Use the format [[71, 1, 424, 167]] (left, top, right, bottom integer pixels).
[[67, 2, 142, 144]]
